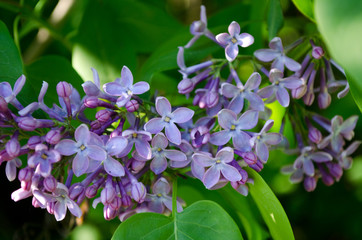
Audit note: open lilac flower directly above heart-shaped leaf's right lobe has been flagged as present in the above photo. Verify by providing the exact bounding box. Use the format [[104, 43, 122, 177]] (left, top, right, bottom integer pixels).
[[192, 147, 241, 189]]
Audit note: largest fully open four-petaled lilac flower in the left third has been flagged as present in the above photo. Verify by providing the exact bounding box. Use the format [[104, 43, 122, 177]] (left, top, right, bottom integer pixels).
[[55, 124, 107, 177]]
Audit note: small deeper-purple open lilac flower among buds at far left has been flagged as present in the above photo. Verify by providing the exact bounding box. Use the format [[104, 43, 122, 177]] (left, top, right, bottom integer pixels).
[[28, 144, 61, 177]]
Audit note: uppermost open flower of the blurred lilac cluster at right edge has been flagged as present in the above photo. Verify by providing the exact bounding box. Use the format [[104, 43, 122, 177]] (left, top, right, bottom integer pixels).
[[318, 115, 358, 153]]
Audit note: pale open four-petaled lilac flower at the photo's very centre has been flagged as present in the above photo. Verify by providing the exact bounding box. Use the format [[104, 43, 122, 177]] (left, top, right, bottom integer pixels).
[[144, 97, 194, 145]]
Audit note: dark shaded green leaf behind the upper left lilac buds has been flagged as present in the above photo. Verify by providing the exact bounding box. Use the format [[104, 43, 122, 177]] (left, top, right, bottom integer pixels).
[[26, 56, 83, 106]]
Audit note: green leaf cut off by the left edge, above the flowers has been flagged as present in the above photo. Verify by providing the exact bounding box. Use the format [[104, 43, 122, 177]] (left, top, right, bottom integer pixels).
[[0, 21, 23, 83]]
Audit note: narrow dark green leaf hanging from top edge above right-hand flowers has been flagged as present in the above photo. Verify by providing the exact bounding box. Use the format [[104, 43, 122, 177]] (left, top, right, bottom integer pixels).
[[267, 0, 283, 41]]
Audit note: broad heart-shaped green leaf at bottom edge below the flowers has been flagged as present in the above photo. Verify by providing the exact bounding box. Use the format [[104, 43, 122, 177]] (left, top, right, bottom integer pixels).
[[112, 200, 243, 240]]
